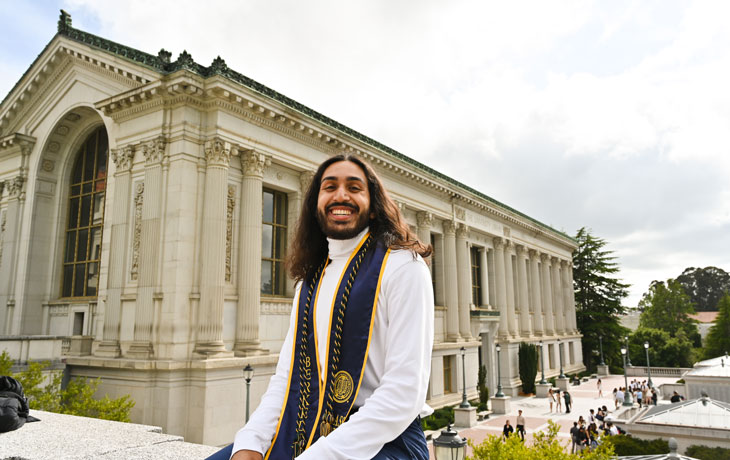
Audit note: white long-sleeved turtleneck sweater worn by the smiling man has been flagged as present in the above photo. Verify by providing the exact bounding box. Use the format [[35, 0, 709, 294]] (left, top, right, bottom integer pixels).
[[233, 229, 434, 460]]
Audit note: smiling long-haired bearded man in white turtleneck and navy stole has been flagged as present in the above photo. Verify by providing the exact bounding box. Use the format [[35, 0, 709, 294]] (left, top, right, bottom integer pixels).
[[212, 156, 434, 460]]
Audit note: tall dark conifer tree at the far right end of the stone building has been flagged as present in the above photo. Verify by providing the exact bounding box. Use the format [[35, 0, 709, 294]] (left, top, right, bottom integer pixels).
[[573, 227, 629, 370]]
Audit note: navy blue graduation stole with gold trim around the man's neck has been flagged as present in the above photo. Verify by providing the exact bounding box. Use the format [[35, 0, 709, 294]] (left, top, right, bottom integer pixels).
[[265, 233, 390, 460]]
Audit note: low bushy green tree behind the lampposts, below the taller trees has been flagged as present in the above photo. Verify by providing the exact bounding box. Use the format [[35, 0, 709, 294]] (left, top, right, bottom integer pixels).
[[629, 327, 694, 367]]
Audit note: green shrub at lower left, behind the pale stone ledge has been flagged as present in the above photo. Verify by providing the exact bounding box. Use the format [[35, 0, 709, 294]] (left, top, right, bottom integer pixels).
[[0, 351, 134, 422]]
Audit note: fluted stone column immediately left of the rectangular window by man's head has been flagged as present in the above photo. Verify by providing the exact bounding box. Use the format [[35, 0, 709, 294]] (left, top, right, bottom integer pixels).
[[233, 150, 268, 356]]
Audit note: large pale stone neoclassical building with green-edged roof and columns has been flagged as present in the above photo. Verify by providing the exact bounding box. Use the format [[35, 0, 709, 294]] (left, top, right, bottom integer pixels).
[[0, 13, 583, 444]]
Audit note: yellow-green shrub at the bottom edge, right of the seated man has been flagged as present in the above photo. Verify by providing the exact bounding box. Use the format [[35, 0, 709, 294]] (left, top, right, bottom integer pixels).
[[467, 420, 615, 460]]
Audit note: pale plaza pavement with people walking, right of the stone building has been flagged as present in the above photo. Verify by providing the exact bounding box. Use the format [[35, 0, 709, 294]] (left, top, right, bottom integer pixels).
[[429, 375, 677, 459]]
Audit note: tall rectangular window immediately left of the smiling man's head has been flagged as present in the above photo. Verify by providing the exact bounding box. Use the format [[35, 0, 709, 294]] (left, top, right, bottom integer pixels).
[[261, 190, 287, 295]]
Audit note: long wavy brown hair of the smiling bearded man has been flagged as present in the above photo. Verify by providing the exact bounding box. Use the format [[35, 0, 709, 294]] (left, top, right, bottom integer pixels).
[[287, 154, 432, 280]]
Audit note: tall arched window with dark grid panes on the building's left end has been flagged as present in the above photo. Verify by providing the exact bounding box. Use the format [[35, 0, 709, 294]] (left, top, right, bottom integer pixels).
[[61, 127, 108, 297]]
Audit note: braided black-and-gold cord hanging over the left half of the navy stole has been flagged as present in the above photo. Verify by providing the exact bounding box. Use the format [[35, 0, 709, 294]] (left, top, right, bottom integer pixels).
[[292, 261, 327, 457]]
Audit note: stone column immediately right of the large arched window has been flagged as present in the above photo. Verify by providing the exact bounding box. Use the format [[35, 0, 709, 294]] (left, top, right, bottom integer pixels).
[[96, 146, 134, 358]]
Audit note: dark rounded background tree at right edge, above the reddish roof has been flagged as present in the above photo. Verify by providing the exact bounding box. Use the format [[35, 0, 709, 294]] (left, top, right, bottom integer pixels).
[[677, 267, 730, 311]]
